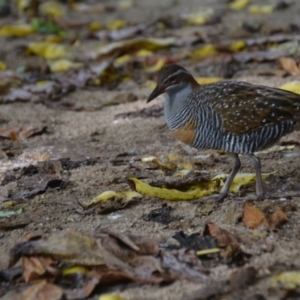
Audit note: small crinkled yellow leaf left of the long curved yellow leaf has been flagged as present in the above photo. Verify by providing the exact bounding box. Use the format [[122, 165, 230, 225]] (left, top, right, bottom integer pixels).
[[81, 191, 142, 208]]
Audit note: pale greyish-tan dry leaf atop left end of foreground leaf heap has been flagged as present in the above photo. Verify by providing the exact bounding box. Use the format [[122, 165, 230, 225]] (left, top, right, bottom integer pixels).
[[10, 231, 104, 266]]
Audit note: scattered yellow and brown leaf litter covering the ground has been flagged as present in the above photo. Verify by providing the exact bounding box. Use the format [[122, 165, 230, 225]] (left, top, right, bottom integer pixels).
[[0, 0, 299, 300]]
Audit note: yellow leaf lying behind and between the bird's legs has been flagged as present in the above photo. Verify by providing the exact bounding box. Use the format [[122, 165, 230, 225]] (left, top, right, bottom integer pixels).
[[211, 173, 271, 193]]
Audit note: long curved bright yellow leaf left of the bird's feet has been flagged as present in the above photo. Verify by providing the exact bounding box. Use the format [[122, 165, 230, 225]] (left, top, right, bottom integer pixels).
[[129, 178, 216, 201]]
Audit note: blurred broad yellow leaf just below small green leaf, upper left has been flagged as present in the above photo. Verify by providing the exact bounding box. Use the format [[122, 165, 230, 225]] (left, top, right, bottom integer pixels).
[[28, 42, 68, 59]]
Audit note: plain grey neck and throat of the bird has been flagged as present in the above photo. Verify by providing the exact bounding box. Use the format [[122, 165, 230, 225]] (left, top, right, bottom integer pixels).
[[164, 84, 193, 120]]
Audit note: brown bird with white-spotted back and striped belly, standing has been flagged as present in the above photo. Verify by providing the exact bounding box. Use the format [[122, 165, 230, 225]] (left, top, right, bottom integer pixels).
[[147, 64, 300, 202]]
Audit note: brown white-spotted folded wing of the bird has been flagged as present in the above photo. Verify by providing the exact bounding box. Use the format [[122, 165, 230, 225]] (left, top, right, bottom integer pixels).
[[198, 81, 300, 135]]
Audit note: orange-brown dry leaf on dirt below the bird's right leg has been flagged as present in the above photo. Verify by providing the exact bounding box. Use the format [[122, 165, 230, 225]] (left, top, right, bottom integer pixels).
[[243, 201, 269, 229]]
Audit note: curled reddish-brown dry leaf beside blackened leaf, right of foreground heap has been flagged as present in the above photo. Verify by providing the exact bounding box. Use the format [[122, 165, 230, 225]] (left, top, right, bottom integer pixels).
[[203, 221, 240, 258]]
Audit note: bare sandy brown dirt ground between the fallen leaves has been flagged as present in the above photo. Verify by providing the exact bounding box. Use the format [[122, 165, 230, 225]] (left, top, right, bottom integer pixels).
[[0, 0, 300, 300]]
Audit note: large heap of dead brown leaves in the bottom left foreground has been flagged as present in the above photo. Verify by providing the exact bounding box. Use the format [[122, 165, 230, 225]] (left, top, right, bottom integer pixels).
[[10, 230, 207, 299]]
